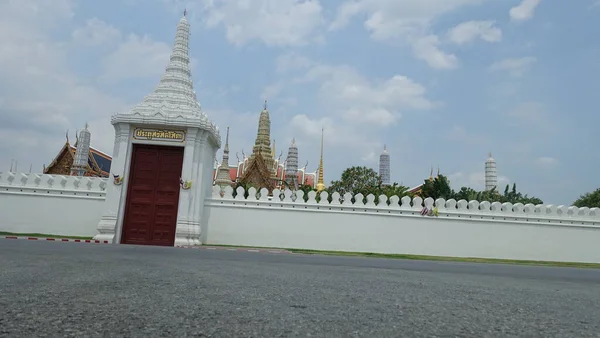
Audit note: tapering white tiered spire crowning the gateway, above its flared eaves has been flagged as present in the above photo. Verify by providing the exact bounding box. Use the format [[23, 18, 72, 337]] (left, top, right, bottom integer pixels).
[[126, 11, 202, 115]]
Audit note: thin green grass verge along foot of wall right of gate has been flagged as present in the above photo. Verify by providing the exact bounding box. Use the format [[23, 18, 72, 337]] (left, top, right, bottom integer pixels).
[[207, 244, 600, 269]]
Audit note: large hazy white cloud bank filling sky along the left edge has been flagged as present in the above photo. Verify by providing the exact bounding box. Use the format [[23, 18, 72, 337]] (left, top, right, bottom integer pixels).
[[0, 0, 148, 172]]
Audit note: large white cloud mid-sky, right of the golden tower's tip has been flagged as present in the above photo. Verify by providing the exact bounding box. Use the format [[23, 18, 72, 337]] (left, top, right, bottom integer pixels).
[[270, 54, 437, 161]]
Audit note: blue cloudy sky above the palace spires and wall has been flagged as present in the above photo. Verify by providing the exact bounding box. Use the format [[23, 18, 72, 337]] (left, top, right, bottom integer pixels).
[[0, 0, 600, 204]]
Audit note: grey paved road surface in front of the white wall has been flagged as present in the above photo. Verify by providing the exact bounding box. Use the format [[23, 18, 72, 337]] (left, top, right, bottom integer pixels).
[[0, 239, 600, 337]]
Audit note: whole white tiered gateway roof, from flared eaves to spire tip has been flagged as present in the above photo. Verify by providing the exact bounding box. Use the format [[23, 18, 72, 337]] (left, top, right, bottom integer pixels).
[[111, 15, 221, 147]]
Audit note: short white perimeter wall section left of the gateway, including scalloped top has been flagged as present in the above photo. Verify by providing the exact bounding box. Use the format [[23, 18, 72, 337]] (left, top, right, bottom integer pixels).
[[0, 173, 106, 237]]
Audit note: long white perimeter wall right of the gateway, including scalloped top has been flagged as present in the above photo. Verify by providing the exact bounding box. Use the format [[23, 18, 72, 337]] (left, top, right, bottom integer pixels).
[[205, 186, 600, 263]]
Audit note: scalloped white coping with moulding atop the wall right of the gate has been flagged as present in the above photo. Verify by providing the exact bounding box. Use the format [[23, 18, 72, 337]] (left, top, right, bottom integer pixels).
[[205, 186, 600, 228]]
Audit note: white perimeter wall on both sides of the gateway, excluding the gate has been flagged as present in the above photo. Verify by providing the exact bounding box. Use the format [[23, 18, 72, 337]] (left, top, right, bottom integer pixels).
[[0, 173, 600, 263]]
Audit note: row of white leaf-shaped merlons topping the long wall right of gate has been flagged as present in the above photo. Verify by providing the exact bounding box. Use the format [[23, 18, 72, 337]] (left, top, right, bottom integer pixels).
[[212, 186, 600, 226]]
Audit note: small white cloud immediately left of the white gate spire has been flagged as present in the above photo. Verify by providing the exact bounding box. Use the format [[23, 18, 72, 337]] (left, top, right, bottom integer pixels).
[[103, 34, 172, 80]]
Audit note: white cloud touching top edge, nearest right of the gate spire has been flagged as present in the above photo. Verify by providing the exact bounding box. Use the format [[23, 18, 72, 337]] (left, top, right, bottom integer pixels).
[[203, 0, 324, 46]]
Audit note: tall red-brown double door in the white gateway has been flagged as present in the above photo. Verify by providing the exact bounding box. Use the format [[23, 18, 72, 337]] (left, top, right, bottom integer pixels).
[[121, 144, 183, 246]]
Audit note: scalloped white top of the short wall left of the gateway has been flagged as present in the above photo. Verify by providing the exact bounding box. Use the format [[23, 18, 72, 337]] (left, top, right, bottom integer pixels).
[[0, 172, 107, 196]]
